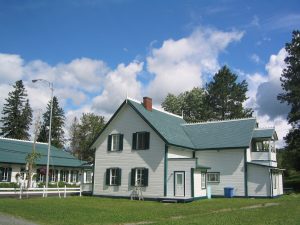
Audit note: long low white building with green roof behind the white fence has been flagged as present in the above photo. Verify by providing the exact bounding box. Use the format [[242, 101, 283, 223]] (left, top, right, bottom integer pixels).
[[0, 137, 92, 186]]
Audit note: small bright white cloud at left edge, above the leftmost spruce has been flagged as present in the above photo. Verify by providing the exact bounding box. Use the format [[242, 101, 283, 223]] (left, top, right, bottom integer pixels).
[[0, 53, 23, 83]]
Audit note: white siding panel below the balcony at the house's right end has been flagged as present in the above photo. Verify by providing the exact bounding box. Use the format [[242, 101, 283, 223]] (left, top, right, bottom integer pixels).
[[247, 164, 271, 197]]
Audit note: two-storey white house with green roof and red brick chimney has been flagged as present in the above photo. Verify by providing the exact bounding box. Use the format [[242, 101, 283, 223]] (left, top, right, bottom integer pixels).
[[92, 97, 283, 201]]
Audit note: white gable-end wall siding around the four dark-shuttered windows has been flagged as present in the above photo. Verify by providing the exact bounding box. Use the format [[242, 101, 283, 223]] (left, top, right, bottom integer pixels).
[[93, 105, 165, 197]]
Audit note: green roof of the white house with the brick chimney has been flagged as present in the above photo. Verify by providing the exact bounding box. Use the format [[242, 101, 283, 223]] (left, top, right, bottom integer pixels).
[[127, 100, 256, 150]]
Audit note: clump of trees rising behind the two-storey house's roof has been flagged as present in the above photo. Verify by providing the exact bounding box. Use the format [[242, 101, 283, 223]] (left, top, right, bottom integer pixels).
[[162, 66, 253, 122]]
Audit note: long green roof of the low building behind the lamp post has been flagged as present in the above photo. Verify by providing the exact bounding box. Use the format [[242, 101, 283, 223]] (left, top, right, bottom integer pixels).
[[0, 138, 86, 167]]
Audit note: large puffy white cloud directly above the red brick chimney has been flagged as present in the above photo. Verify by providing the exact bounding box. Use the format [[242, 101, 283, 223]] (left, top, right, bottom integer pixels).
[[147, 28, 243, 101]]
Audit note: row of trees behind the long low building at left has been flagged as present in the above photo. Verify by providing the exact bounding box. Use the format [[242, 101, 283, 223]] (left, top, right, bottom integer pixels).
[[0, 80, 105, 161]]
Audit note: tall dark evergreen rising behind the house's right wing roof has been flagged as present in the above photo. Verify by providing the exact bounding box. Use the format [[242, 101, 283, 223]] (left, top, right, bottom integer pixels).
[[206, 66, 253, 120]]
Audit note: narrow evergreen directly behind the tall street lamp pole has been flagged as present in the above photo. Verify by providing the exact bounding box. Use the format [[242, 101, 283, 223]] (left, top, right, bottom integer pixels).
[[37, 96, 65, 148]]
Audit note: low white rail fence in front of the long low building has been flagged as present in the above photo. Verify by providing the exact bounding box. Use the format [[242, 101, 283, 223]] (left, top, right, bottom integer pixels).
[[0, 186, 82, 199]]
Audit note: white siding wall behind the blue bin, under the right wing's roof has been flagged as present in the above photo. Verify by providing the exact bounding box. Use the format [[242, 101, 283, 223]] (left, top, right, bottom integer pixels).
[[196, 149, 245, 196]]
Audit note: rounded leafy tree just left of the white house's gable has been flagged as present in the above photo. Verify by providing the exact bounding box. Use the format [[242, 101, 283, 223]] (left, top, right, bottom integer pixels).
[[70, 113, 105, 161]]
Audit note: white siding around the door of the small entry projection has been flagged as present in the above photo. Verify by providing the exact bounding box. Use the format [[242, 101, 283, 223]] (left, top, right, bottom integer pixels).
[[167, 159, 196, 198]]
